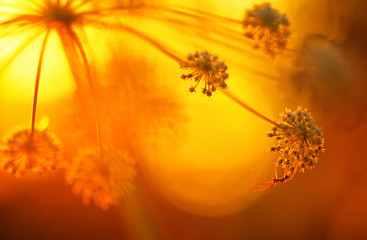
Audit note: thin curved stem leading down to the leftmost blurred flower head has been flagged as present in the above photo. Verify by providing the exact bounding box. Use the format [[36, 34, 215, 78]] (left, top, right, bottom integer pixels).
[[30, 29, 50, 141]]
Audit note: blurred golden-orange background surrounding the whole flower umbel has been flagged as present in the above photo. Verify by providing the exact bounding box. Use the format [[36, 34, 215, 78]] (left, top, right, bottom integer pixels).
[[0, 0, 367, 240]]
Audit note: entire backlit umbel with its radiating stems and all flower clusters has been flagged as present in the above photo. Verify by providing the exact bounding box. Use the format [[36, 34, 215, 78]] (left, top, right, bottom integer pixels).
[[0, 0, 323, 204]]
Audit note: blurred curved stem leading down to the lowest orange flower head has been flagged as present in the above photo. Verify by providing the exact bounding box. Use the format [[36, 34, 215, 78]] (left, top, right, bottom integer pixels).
[[67, 28, 103, 158]]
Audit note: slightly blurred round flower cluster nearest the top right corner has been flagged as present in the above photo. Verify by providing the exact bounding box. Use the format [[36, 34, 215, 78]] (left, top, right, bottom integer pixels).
[[242, 3, 290, 56]]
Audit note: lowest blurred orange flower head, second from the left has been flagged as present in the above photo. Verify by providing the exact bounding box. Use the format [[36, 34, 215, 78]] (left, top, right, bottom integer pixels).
[[65, 148, 135, 210]]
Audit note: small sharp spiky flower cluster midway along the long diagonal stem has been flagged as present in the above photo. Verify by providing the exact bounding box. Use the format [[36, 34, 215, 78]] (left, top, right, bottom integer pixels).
[[181, 51, 228, 97]]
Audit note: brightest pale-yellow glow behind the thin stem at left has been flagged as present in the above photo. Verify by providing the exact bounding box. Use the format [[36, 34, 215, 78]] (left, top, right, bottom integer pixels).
[[1, 32, 75, 103]]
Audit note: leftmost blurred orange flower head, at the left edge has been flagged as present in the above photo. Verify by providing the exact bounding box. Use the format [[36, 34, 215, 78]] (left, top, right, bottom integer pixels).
[[0, 129, 62, 177]]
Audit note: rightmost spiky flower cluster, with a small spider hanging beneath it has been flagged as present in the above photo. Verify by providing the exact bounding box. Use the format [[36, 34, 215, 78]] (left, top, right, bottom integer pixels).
[[268, 107, 324, 177]]
